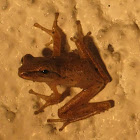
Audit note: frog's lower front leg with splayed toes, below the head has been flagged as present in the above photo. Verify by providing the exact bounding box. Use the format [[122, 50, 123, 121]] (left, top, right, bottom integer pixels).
[[29, 88, 70, 114]]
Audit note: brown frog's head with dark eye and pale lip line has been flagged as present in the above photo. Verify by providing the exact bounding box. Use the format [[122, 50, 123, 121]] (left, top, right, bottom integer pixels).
[[18, 54, 60, 82]]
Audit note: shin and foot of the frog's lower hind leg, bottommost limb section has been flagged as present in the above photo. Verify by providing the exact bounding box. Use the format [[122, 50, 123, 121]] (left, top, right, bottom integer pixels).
[[47, 100, 114, 131]]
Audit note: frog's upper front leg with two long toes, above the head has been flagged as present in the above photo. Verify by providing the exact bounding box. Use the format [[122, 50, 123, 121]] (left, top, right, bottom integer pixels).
[[34, 13, 67, 57]]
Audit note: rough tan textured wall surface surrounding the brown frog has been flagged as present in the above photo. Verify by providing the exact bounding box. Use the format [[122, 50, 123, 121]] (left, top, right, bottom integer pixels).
[[0, 0, 140, 140]]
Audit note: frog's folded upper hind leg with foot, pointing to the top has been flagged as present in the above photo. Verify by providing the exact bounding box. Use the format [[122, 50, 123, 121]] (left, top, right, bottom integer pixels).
[[71, 20, 112, 84]]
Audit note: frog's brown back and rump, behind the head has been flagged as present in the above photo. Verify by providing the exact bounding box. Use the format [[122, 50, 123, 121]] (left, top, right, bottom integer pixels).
[[60, 54, 103, 88]]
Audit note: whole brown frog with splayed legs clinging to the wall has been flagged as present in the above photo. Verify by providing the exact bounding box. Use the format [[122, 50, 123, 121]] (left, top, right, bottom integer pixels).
[[18, 13, 114, 131]]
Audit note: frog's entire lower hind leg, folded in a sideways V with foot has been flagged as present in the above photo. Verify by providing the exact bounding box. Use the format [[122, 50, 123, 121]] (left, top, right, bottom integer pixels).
[[48, 82, 114, 131]]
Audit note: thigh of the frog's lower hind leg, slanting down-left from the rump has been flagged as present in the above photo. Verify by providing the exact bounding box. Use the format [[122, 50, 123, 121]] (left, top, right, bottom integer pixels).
[[58, 82, 104, 119]]
